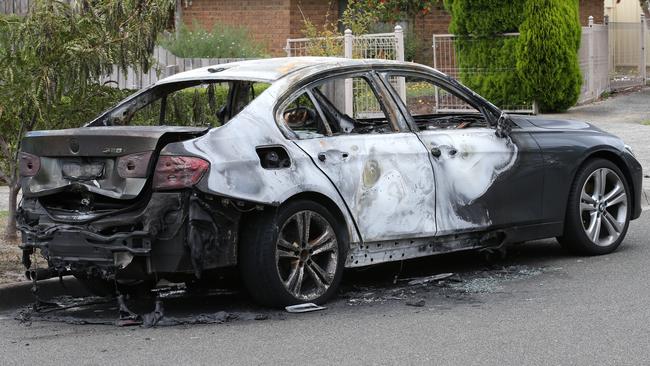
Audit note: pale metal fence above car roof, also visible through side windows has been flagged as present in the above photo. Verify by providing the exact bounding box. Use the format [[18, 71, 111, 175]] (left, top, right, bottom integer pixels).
[[284, 25, 405, 117]]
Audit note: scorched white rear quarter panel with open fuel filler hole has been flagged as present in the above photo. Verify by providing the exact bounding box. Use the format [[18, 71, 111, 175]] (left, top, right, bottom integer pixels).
[[156, 85, 360, 243]]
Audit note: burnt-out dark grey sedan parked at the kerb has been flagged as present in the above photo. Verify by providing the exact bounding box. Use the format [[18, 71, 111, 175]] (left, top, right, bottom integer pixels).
[[18, 58, 642, 306]]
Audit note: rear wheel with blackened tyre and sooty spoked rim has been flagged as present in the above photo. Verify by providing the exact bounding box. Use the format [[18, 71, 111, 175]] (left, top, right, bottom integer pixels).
[[239, 200, 348, 307]]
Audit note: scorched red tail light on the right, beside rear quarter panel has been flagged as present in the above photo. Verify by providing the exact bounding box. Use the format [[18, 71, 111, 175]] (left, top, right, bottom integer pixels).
[[153, 155, 210, 190]]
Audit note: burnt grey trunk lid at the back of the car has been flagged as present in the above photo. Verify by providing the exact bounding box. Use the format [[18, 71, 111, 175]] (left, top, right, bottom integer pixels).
[[21, 126, 207, 217]]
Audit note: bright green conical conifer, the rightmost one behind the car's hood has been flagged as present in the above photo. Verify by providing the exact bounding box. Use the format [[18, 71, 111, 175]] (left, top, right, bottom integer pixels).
[[516, 0, 582, 112]]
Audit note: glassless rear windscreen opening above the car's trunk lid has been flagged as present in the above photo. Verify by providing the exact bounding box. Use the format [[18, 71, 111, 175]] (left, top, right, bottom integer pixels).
[[90, 80, 270, 127]]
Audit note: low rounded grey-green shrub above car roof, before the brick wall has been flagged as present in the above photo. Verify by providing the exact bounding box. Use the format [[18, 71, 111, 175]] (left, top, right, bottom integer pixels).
[[160, 22, 267, 58]]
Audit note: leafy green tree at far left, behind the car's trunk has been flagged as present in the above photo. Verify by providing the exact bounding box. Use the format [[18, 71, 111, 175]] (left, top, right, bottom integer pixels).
[[0, 0, 175, 237]]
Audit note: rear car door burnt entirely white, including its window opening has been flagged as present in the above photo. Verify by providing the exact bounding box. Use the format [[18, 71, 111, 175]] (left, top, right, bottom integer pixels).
[[280, 73, 436, 242]]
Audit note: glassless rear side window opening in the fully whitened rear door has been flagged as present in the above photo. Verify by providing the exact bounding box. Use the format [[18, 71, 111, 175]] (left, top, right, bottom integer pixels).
[[283, 77, 396, 139]]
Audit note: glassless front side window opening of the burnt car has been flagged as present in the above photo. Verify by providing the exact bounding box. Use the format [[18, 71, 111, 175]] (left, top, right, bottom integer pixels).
[[388, 75, 488, 130]]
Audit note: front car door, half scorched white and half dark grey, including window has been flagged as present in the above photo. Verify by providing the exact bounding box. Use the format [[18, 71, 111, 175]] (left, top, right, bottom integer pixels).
[[384, 73, 544, 235]]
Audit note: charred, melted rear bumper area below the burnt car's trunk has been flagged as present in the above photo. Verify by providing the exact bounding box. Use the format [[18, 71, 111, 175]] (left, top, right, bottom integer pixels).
[[18, 190, 255, 281]]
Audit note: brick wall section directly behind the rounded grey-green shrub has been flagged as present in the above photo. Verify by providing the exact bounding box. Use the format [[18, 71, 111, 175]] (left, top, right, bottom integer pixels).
[[177, 0, 292, 55]]
